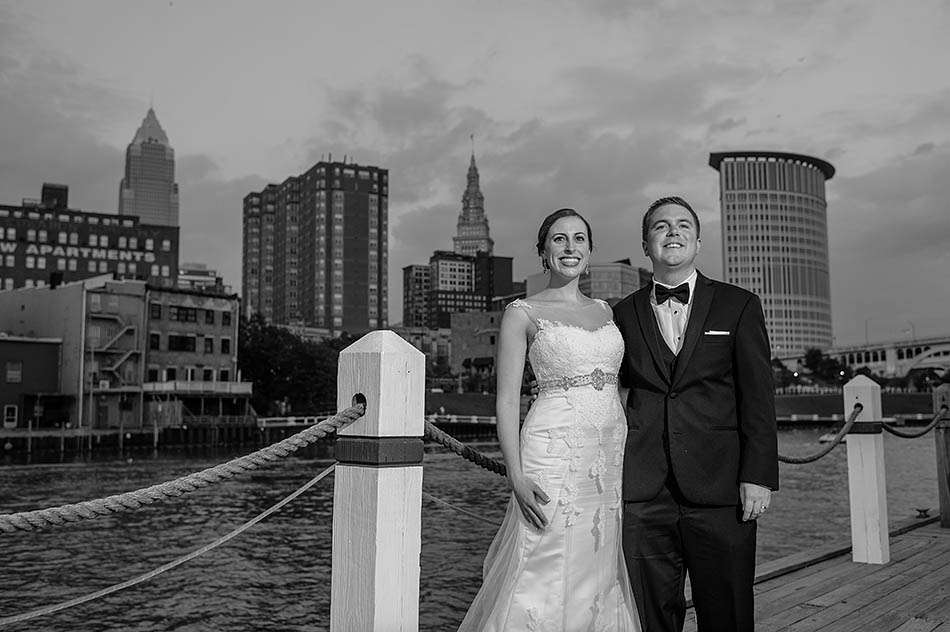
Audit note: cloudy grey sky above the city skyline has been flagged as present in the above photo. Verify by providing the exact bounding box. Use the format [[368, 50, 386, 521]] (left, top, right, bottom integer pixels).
[[0, 0, 950, 344]]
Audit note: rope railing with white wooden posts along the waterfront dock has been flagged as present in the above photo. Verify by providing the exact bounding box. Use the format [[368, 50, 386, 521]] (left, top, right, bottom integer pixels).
[[0, 331, 950, 632]]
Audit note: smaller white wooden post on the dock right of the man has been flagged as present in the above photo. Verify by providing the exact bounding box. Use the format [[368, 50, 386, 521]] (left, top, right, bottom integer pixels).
[[844, 375, 891, 564]]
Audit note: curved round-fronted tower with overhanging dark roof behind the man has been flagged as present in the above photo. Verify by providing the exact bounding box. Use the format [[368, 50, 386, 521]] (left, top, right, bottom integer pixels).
[[709, 151, 835, 356]]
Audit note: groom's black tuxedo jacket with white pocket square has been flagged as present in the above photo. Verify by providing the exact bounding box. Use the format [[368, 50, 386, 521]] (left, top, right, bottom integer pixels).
[[614, 274, 778, 505]]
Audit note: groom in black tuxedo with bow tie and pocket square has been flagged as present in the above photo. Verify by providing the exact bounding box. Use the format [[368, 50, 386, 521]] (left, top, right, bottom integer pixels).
[[614, 197, 778, 632]]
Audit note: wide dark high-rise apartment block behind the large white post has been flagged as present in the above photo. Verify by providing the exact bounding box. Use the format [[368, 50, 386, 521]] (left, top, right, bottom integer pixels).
[[242, 161, 389, 334]]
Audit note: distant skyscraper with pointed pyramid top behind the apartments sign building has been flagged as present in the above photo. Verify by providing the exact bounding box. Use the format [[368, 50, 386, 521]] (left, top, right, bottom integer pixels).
[[119, 108, 178, 226]]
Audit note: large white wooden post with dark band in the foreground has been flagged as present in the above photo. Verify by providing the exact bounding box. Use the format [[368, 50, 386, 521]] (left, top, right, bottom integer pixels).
[[330, 331, 425, 632]]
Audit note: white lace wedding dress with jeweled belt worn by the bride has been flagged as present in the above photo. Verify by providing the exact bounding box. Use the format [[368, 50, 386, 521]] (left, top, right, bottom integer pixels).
[[459, 300, 640, 632]]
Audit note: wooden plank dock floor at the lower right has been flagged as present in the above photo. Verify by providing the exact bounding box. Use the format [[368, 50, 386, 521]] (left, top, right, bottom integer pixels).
[[685, 519, 950, 632]]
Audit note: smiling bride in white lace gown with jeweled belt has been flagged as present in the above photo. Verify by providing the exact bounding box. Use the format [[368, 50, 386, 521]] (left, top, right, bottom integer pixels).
[[459, 208, 640, 632]]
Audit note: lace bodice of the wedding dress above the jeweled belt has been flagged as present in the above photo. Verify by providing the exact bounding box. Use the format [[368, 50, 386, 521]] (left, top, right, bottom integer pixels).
[[508, 299, 623, 381]]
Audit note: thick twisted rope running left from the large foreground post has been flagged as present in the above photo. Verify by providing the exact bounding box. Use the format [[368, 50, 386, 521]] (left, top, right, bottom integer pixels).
[[0, 404, 366, 533]]
